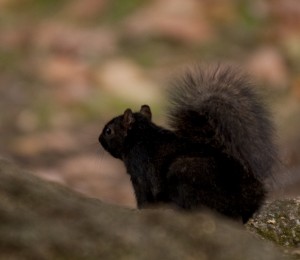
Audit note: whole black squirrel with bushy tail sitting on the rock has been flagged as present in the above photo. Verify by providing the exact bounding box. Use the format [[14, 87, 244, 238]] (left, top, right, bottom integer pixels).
[[99, 66, 277, 223]]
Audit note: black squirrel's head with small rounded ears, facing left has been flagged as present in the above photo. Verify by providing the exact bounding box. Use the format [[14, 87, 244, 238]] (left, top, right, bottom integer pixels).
[[99, 105, 152, 159]]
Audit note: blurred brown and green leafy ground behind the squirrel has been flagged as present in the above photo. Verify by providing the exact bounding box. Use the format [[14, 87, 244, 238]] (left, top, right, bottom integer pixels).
[[0, 0, 300, 207]]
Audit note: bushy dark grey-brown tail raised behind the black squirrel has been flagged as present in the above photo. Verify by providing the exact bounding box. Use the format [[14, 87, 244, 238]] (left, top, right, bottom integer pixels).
[[169, 66, 278, 179]]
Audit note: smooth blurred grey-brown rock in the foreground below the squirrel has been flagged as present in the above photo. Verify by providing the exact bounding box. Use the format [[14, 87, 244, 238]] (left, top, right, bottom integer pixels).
[[0, 160, 284, 260]]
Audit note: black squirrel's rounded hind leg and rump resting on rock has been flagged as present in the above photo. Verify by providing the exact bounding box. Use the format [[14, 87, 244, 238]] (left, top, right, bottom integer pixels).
[[166, 157, 265, 223]]
